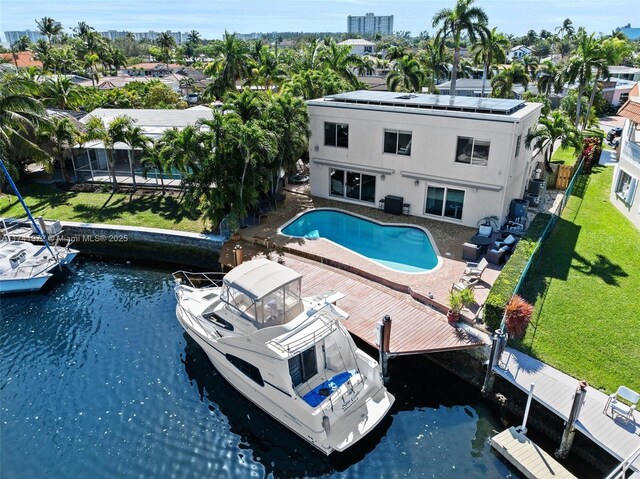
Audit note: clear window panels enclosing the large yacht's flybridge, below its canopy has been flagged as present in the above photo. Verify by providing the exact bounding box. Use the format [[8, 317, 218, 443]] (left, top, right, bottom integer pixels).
[[221, 278, 303, 329]]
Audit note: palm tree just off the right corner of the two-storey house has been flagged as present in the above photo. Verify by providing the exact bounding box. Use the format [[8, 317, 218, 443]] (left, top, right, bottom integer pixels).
[[524, 110, 582, 171]]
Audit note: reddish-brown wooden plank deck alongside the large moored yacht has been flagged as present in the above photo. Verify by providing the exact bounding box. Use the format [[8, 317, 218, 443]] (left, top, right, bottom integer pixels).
[[282, 256, 482, 355]]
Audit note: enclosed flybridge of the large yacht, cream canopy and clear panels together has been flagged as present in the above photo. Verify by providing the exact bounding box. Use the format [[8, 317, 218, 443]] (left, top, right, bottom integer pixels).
[[221, 259, 303, 329]]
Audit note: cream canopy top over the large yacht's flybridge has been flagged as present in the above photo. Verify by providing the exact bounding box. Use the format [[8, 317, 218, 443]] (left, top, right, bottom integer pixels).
[[224, 258, 302, 300]]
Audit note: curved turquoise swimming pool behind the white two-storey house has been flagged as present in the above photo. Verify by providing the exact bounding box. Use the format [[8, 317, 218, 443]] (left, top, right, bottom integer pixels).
[[280, 209, 440, 273]]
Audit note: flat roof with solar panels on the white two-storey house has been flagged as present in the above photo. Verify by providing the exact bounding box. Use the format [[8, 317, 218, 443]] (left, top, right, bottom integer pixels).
[[318, 90, 526, 115]]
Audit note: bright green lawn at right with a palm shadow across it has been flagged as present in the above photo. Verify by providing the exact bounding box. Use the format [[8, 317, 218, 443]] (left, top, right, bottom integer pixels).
[[515, 167, 640, 393]]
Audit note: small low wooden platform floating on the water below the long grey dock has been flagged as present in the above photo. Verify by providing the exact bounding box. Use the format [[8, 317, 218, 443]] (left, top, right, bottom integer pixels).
[[491, 427, 575, 479]]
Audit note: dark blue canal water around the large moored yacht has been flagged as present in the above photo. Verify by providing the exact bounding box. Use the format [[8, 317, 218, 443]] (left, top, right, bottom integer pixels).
[[0, 257, 520, 479]]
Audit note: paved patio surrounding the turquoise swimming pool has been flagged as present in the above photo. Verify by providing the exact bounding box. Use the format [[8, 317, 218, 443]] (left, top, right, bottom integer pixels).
[[235, 186, 501, 322]]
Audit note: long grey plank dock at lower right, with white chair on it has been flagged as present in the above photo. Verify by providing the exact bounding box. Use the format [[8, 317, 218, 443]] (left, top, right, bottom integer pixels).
[[493, 348, 640, 471]]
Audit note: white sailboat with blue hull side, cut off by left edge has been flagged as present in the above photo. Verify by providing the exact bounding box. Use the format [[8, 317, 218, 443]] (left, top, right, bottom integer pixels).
[[0, 241, 78, 294]]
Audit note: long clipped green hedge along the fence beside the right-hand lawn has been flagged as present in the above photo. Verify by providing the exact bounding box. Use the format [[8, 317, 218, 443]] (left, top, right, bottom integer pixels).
[[484, 213, 551, 331]]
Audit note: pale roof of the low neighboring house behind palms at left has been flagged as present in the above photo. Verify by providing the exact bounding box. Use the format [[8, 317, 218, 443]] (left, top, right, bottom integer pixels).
[[81, 108, 213, 137]]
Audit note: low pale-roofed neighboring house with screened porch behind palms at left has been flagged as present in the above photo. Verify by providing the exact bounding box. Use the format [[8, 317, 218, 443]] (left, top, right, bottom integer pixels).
[[74, 107, 213, 181]]
